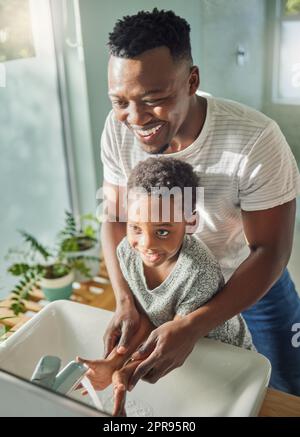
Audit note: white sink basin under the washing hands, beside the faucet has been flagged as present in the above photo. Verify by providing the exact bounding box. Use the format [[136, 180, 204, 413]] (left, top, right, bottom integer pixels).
[[0, 301, 271, 417]]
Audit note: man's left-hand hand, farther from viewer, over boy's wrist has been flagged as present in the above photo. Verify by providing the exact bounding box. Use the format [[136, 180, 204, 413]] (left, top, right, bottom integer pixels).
[[103, 304, 141, 358]]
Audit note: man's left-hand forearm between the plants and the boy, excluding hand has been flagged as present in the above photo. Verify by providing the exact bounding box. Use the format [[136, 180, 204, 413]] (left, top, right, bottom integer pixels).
[[101, 222, 134, 304]]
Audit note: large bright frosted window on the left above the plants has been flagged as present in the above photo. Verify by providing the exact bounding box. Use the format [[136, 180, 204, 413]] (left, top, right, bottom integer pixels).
[[0, 0, 70, 297]]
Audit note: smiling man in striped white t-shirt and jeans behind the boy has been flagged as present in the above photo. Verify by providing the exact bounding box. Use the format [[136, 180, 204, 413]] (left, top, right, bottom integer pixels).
[[101, 9, 300, 395]]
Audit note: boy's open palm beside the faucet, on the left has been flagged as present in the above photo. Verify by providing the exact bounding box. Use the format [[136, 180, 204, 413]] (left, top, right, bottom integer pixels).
[[76, 357, 114, 395]]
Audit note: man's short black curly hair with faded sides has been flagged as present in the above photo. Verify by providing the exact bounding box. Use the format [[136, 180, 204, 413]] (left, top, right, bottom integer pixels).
[[108, 8, 193, 64]]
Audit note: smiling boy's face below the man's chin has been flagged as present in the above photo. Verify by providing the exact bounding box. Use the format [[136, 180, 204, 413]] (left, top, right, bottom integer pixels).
[[127, 195, 186, 267]]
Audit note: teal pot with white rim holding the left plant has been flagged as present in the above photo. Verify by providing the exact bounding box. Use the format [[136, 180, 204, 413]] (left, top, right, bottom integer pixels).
[[40, 271, 74, 302]]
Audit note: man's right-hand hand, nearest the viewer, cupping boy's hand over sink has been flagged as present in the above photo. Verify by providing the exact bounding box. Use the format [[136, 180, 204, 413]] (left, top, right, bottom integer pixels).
[[129, 318, 198, 391]]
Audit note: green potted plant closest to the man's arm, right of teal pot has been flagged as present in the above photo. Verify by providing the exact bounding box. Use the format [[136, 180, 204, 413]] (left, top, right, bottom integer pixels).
[[58, 211, 100, 281]]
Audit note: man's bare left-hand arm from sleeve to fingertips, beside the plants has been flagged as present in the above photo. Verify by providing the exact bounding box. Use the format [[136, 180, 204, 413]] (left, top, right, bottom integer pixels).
[[101, 182, 140, 356]]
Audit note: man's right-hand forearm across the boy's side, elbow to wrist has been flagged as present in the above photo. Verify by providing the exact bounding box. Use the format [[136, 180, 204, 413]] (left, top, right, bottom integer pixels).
[[186, 249, 286, 337]]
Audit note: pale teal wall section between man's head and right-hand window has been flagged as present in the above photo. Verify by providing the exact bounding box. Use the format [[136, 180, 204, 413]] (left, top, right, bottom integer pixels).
[[200, 0, 265, 110]]
